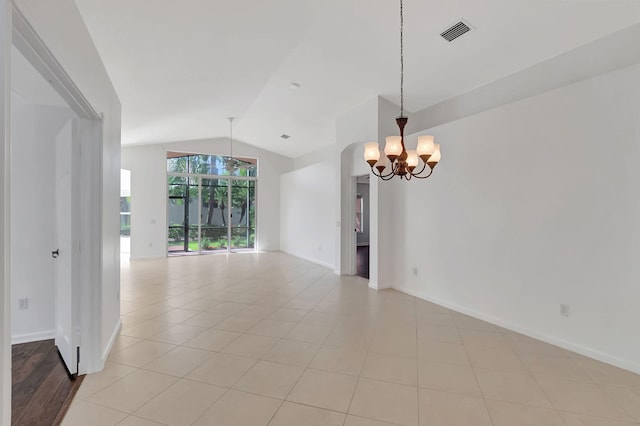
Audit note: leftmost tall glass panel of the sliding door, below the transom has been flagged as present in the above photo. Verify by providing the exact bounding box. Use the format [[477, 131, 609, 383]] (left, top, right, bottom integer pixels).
[[167, 176, 199, 254]]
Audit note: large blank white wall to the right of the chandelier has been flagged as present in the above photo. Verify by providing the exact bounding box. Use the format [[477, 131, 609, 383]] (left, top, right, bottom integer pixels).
[[393, 65, 640, 373]]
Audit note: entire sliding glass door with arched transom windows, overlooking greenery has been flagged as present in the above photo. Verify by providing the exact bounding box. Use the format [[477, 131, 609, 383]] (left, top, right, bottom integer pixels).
[[167, 153, 257, 255]]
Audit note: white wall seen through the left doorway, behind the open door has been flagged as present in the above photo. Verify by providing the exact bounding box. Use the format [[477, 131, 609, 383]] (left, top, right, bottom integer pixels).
[[11, 94, 75, 343]]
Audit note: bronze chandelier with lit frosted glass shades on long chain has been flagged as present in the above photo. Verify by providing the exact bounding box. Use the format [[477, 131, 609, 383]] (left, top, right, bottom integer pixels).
[[364, 0, 440, 180]]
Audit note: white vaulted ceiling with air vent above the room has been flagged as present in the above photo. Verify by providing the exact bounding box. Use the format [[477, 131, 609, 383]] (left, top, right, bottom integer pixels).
[[76, 0, 640, 157]]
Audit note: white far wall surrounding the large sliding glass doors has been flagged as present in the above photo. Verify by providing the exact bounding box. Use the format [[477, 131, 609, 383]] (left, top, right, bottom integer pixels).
[[122, 139, 293, 259]]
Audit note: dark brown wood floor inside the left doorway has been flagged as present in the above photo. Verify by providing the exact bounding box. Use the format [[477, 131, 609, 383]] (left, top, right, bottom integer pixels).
[[11, 340, 84, 426]]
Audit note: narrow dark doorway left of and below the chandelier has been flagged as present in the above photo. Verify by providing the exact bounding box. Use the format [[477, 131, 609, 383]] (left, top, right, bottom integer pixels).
[[355, 175, 371, 279]]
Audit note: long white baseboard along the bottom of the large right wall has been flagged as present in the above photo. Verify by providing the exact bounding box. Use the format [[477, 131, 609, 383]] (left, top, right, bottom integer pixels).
[[393, 286, 640, 374]]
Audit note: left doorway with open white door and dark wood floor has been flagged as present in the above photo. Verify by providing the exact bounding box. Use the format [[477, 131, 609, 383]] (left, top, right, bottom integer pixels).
[[9, 35, 92, 424]]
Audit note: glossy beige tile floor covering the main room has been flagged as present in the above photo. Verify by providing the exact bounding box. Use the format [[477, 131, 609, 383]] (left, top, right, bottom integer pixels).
[[63, 253, 640, 426]]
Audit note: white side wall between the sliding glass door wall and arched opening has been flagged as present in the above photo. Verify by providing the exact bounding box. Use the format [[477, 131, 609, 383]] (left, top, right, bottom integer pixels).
[[280, 161, 336, 268]]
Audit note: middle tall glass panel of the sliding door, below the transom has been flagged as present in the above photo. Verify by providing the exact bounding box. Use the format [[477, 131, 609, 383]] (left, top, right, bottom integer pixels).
[[200, 179, 229, 252]]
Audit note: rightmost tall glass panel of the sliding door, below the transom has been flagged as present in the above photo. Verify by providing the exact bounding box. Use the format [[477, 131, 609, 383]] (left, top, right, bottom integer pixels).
[[231, 180, 256, 249]]
